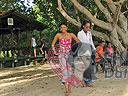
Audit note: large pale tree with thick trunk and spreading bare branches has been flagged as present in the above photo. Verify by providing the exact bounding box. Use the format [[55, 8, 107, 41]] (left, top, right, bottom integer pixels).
[[58, 0, 128, 53]]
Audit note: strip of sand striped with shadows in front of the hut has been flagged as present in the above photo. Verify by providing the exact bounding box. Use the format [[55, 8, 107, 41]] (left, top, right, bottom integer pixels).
[[0, 66, 53, 84]]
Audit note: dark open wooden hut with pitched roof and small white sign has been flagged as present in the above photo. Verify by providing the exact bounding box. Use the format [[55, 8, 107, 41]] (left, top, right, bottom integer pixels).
[[0, 10, 47, 67]]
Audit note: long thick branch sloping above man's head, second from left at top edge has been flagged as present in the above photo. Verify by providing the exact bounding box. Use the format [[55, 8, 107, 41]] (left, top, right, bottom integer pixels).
[[70, 0, 112, 31]]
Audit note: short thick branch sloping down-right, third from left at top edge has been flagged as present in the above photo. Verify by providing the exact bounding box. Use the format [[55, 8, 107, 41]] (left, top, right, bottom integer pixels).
[[94, 0, 113, 22]]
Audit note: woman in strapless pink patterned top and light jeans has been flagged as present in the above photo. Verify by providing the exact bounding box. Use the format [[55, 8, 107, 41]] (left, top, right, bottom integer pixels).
[[52, 23, 79, 96]]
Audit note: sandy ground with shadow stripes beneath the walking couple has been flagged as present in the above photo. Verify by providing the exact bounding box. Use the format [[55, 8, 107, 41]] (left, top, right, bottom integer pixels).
[[0, 64, 128, 96]]
